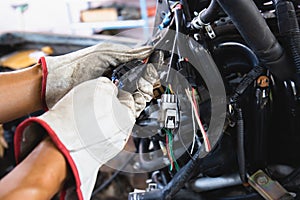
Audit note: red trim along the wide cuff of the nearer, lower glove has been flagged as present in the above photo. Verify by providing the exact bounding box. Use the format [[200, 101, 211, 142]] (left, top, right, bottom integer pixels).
[[14, 117, 85, 200]]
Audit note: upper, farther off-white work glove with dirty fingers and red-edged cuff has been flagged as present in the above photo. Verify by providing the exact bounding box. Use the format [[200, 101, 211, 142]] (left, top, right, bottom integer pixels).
[[40, 43, 152, 109]]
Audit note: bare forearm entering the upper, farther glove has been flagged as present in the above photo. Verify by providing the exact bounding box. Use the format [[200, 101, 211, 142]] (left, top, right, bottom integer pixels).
[[0, 64, 42, 123]]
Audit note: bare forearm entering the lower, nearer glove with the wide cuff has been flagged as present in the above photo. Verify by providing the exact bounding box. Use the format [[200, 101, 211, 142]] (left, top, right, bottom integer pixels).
[[0, 138, 67, 200]]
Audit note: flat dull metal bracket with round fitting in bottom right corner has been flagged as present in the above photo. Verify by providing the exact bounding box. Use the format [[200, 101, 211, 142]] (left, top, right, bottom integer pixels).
[[249, 170, 294, 200]]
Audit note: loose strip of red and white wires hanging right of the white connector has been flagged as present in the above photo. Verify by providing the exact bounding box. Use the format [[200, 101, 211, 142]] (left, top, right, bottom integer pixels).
[[185, 88, 211, 152]]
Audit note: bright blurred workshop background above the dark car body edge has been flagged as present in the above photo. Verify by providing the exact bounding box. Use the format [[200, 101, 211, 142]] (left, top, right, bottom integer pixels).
[[0, 0, 156, 37]]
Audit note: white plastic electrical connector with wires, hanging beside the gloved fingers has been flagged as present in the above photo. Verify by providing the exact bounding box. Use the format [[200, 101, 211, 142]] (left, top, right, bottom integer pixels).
[[159, 94, 179, 129]]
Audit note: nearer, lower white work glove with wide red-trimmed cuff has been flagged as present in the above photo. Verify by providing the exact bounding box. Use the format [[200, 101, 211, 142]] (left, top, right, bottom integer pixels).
[[15, 65, 158, 200]]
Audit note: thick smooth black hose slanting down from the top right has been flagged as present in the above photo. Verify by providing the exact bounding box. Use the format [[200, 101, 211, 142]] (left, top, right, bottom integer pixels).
[[217, 0, 294, 79]]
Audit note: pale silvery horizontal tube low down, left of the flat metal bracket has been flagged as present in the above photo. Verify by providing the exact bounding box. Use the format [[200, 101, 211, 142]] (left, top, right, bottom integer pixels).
[[190, 174, 242, 192]]
